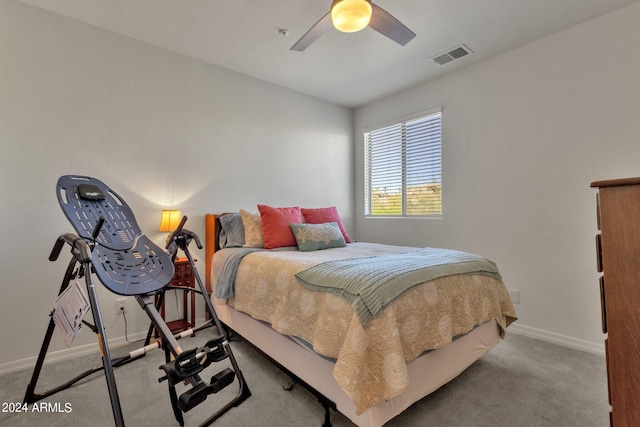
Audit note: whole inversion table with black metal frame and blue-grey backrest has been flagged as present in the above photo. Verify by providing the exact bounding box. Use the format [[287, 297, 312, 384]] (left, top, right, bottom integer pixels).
[[24, 175, 251, 426]]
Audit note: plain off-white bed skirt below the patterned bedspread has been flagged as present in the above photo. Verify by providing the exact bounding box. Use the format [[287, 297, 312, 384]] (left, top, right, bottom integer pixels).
[[213, 298, 500, 427]]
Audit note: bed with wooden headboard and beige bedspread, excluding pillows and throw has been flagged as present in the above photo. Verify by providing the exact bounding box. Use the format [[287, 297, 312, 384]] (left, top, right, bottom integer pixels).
[[205, 211, 516, 427]]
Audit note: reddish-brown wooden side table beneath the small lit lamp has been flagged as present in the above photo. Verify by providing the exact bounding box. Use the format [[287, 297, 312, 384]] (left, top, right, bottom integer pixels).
[[160, 258, 196, 335]]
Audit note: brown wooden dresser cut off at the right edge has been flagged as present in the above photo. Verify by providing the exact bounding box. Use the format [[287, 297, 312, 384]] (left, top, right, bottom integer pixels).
[[591, 178, 640, 427]]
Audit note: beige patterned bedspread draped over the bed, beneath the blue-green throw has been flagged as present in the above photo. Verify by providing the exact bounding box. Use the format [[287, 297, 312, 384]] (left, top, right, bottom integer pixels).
[[213, 243, 516, 414]]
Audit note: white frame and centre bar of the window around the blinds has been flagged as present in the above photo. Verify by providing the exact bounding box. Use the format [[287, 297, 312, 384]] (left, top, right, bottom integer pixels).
[[363, 107, 444, 219]]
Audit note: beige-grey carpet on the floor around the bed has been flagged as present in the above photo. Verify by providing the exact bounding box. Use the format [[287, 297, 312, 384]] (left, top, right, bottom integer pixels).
[[0, 331, 609, 427]]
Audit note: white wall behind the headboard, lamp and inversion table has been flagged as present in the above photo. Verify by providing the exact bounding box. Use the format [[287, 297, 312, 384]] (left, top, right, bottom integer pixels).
[[0, 0, 353, 369]]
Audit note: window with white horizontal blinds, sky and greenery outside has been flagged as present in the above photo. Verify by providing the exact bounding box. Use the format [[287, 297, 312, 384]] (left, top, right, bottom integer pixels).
[[364, 109, 442, 217]]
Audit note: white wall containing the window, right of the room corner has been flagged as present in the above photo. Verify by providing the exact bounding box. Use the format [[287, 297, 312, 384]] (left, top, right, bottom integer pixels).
[[355, 3, 640, 348]]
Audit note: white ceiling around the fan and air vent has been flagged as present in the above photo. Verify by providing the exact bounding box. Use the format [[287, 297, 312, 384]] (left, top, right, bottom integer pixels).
[[15, 0, 638, 107]]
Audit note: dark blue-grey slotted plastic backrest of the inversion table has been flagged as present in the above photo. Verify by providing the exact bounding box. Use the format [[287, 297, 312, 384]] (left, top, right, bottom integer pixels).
[[57, 175, 174, 295]]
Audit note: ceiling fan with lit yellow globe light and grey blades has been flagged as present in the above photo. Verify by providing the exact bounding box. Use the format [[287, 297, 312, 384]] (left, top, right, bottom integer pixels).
[[291, 0, 416, 52]]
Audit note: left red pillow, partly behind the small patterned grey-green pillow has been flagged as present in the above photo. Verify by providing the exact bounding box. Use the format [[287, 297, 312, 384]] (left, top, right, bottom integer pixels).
[[258, 205, 302, 249]]
